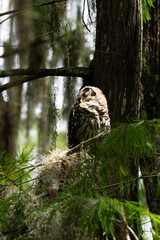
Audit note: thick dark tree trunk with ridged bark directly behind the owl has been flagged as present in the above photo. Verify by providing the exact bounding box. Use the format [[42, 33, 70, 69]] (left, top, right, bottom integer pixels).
[[88, 0, 143, 123]]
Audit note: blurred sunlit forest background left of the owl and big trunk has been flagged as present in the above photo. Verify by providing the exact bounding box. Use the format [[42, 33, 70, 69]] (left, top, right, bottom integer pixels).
[[0, 0, 91, 155]]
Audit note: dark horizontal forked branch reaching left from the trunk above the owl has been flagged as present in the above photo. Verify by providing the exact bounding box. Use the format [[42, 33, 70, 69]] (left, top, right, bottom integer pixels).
[[0, 67, 90, 92]]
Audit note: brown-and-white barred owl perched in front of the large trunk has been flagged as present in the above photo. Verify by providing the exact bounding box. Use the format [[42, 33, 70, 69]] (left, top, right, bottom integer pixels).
[[68, 86, 110, 148]]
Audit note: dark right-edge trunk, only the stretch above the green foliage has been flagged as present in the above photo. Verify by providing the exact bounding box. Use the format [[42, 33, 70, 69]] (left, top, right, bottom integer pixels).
[[142, 0, 160, 119]]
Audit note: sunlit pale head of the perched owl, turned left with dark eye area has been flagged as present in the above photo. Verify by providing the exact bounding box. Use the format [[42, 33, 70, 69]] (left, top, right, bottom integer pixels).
[[77, 86, 106, 103]]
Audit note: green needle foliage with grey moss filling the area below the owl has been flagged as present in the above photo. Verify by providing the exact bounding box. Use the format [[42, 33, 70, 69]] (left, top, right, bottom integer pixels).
[[0, 120, 160, 240]]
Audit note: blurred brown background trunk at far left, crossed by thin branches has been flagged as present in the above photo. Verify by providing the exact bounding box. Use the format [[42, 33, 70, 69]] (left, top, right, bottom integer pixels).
[[0, 0, 33, 155]]
